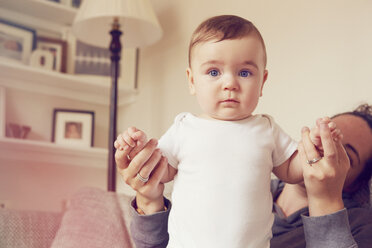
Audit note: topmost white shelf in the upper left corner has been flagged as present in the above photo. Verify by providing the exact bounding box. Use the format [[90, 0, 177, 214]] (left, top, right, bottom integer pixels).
[[0, 0, 77, 30]]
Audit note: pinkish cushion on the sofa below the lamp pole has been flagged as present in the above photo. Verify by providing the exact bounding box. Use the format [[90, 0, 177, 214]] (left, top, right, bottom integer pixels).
[[51, 188, 133, 248]]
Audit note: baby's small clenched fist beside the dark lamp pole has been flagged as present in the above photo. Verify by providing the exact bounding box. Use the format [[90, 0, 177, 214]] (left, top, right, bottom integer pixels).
[[114, 127, 147, 151]]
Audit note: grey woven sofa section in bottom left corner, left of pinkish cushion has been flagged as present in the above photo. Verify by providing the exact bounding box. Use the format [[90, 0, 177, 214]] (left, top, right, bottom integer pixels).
[[0, 209, 62, 248]]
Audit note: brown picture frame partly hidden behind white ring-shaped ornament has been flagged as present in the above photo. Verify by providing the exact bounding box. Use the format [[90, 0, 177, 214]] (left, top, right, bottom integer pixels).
[[37, 36, 67, 72]]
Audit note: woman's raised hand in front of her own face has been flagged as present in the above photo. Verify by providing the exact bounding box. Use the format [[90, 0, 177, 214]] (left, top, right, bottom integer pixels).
[[299, 122, 350, 216]]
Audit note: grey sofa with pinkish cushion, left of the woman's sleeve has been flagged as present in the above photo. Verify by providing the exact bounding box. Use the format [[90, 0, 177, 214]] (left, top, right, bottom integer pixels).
[[0, 188, 134, 248]]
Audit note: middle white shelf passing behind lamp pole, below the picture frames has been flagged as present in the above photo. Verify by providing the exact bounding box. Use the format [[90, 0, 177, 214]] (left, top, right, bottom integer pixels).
[[0, 58, 137, 106]]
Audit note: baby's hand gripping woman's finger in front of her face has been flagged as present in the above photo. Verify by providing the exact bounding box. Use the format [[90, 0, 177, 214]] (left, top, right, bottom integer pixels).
[[310, 117, 343, 151]]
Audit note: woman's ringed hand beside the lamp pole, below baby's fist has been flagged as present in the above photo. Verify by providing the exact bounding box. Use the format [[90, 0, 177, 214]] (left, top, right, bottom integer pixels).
[[115, 139, 168, 214]]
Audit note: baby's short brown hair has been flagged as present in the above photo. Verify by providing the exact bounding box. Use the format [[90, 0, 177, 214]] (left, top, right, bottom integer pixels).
[[189, 15, 267, 67]]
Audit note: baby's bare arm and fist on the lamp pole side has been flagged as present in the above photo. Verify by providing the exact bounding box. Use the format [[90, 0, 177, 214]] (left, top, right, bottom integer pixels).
[[114, 127, 177, 183]]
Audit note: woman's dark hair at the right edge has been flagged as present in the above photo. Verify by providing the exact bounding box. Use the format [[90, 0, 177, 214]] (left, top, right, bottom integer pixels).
[[332, 104, 372, 202]]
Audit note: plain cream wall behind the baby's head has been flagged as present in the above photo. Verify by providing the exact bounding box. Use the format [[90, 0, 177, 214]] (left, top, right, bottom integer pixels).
[[119, 0, 372, 194]]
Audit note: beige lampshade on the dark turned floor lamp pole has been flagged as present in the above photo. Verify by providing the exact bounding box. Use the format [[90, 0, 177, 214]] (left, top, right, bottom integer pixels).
[[72, 0, 162, 48]]
